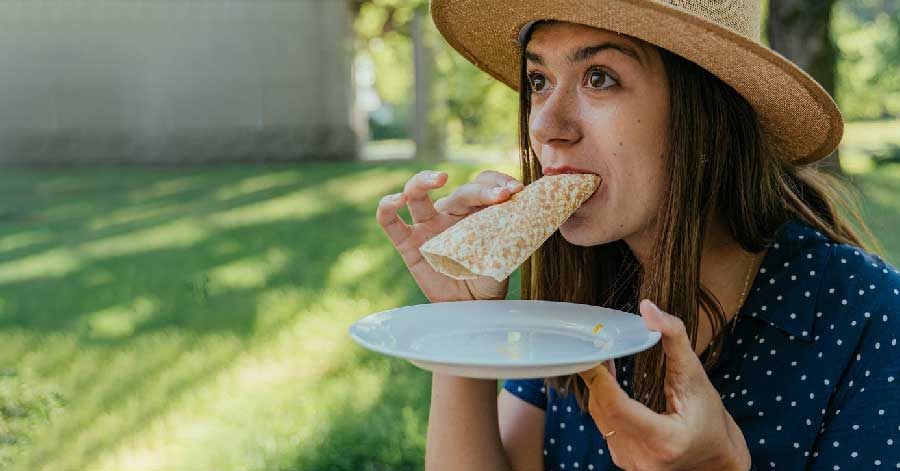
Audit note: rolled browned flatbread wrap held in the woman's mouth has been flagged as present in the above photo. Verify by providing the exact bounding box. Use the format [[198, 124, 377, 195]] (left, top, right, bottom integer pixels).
[[419, 173, 600, 281]]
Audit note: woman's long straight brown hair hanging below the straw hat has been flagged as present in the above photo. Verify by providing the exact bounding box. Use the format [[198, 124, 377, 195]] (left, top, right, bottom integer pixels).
[[519, 23, 875, 412]]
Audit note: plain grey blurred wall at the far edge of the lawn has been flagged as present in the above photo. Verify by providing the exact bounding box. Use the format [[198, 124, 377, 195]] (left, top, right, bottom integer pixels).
[[0, 0, 359, 163]]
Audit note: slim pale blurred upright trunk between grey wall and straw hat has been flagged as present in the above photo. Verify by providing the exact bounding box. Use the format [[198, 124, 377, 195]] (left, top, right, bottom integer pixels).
[[411, 5, 446, 161]]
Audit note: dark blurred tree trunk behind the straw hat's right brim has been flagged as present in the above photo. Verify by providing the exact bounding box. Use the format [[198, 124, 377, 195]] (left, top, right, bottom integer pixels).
[[766, 0, 843, 174]]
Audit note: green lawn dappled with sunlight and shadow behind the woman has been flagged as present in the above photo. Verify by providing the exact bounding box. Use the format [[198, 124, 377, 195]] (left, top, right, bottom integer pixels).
[[0, 150, 900, 470]]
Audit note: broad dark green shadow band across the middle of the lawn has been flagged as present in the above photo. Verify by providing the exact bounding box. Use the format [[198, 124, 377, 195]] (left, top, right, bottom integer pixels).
[[0, 206, 363, 336]]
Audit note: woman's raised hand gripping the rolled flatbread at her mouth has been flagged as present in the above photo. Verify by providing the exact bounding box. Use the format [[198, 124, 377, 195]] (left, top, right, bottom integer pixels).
[[376, 171, 524, 302]]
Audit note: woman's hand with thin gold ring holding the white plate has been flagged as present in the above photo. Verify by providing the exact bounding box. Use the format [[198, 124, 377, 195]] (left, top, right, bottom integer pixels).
[[579, 300, 750, 471]]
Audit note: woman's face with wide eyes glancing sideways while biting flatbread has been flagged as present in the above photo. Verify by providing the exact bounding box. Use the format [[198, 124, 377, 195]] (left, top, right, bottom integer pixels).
[[525, 23, 669, 252]]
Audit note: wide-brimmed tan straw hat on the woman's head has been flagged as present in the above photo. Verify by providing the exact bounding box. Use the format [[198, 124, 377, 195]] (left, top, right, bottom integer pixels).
[[431, 0, 844, 163]]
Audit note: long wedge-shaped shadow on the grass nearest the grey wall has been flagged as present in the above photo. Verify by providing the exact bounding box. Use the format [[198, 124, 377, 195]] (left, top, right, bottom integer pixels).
[[0, 165, 372, 268]]
